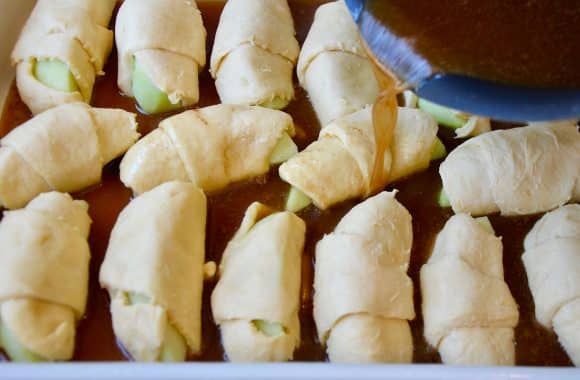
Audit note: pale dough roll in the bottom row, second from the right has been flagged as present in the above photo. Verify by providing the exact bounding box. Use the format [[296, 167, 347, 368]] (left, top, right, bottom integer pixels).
[[421, 214, 519, 365]]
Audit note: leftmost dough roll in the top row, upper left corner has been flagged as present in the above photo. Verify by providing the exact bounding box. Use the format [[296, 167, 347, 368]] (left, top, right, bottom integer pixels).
[[11, 0, 116, 114]]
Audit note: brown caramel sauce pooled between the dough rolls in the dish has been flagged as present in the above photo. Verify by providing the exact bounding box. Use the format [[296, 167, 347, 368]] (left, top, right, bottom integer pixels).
[[0, 0, 571, 366]]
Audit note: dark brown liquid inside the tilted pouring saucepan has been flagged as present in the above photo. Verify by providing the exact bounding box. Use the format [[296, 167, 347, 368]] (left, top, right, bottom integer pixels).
[[366, 0, 580, 88]]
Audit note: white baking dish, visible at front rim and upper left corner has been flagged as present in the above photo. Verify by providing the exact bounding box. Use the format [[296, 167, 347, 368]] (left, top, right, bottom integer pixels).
[[0, 0, 580, 380]]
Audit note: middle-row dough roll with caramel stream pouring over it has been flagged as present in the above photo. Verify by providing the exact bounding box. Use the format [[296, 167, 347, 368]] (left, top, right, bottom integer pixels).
[[279, 107, 437, 209]]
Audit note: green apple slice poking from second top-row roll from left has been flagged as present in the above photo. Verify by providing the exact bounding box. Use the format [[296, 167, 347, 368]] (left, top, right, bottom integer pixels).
[[132, 59, 181, 114]]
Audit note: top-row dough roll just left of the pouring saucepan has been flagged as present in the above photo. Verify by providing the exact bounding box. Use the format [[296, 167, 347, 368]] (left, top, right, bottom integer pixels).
[[297, 1, 379, 125]]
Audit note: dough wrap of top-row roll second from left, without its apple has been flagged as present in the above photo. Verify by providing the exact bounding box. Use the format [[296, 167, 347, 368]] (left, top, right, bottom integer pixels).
[[115, 0, 206, 107]]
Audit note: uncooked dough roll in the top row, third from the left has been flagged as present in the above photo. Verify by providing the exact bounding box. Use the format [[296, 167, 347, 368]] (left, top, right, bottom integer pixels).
[[211, 0, 300, 109]]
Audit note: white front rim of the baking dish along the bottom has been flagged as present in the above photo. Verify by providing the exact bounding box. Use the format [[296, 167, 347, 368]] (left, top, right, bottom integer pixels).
[[0, 363, 580, 380]]
